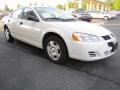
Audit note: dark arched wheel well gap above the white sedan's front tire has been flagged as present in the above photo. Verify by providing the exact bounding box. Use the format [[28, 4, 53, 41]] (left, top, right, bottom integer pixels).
[[42, 32, 68, 53]]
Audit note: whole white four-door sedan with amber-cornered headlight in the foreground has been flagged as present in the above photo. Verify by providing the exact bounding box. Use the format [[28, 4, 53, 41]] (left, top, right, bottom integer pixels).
[[3, 7, 118, 64]]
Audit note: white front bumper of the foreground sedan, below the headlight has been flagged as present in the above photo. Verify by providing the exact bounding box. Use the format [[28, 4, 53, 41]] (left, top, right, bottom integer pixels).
[[69, 40, 118, 61]]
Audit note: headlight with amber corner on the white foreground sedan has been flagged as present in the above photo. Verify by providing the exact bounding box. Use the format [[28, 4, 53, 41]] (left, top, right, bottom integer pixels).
[[72, 32, 100, 42]]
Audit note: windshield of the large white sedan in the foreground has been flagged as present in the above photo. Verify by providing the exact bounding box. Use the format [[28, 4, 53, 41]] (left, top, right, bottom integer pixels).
[[35, 7, 75, 21]]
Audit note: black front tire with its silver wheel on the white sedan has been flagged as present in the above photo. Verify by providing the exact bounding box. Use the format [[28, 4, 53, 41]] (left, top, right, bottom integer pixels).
[[44, 35, 68, 64]]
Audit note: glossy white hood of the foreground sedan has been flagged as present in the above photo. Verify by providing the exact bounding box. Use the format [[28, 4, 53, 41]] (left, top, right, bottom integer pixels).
[[47, 21, 111, 36]]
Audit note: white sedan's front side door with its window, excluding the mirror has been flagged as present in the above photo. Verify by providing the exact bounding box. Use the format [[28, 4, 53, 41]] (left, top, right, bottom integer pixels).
[[20, 8, 41, 47]]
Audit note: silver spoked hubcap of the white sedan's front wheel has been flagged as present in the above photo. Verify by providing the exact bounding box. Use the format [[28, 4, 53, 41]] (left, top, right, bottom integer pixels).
[[47, 41, 61, 60]]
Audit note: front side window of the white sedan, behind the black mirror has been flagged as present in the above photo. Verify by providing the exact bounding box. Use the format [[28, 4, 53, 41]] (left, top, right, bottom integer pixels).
[[22, 8, 37, 20]]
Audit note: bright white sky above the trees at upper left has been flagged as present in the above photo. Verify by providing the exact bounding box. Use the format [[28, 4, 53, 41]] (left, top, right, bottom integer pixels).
[[0, 0, 103, 9]]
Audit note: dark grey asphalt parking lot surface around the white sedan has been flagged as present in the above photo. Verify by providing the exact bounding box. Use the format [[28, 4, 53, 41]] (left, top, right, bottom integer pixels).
[[0, 17, 120, 90]]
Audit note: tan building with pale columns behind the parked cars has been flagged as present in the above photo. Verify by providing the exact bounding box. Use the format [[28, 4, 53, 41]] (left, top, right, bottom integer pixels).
[[75, 0, 111, 11]]
